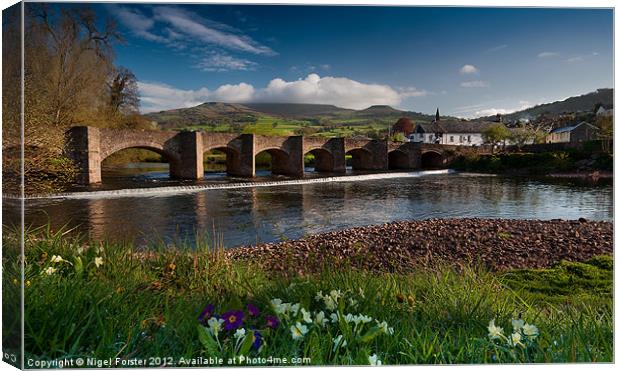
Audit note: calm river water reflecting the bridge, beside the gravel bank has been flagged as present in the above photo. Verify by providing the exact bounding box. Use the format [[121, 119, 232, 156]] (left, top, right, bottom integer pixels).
[[3, 166, 613, 247]]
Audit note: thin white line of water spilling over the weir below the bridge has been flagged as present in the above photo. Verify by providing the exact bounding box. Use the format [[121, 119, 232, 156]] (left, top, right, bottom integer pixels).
[[19, 169, 455, 200]]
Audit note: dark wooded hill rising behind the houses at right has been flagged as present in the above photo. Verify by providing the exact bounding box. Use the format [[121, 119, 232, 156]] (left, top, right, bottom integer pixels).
[[483, 89, 614, 121]]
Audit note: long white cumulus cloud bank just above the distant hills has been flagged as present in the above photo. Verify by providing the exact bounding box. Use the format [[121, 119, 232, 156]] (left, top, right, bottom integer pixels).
[[138, 73, 427, 112]]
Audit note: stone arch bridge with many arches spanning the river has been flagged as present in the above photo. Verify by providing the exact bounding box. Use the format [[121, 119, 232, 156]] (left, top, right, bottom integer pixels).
[[66, 126, 486, 184]]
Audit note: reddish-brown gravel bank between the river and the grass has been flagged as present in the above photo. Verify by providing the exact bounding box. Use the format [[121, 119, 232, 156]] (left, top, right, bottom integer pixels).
[[228, 219, 613, 273]]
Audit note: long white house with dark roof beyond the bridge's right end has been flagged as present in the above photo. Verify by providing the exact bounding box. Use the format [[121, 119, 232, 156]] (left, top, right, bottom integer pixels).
[[409, 120, 498, 146]]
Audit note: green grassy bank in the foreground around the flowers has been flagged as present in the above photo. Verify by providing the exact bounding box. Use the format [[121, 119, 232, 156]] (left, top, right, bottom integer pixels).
[[3, 229, 613, 365]]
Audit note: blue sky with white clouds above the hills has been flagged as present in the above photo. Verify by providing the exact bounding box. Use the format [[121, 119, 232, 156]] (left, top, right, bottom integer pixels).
[[96, 4, 613, 117]]
